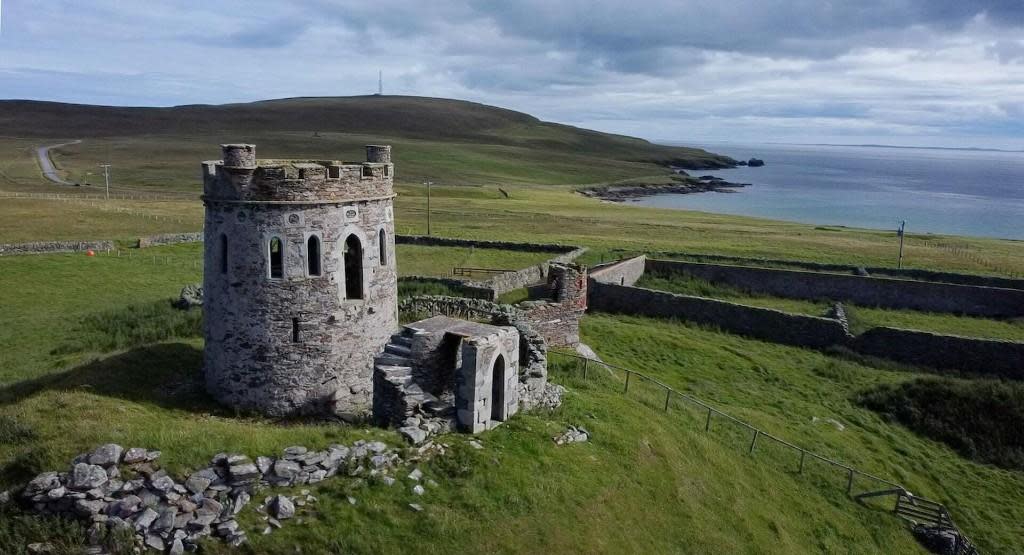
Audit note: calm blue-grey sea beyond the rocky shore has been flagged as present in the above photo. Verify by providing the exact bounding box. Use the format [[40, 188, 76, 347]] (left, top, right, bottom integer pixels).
[[634, 143, 1024, 240]]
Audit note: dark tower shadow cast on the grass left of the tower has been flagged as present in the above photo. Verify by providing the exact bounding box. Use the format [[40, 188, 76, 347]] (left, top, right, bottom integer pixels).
[[0, 343, 223, 413]]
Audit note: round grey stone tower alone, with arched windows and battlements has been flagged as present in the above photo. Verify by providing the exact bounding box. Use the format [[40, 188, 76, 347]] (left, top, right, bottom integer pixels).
[[203, 144, 398, 416]]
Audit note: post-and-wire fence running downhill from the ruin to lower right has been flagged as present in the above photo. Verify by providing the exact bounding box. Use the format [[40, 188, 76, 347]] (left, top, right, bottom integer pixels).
[[548, 350, 978, 555]]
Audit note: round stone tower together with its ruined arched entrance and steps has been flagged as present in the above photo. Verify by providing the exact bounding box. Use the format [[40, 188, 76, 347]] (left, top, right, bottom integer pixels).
[[203, 144, 561, 440]]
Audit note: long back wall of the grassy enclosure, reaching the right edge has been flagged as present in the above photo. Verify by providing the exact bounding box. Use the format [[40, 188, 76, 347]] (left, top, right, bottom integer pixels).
[[646, 259, 1024, 317]]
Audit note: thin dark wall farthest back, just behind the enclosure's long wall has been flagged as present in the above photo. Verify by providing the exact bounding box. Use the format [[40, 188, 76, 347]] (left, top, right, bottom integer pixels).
[[648, 251, 1024, 289]]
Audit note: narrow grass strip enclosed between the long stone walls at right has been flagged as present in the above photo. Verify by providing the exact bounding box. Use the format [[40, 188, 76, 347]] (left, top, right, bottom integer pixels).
[[637, 273, 1024, 341]]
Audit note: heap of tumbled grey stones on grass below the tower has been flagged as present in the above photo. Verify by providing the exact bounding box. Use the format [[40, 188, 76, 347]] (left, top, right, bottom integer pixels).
[[6, 440, 425, 555]]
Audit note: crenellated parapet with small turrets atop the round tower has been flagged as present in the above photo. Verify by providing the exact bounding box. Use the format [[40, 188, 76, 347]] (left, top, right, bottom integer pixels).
[[203, 144, 394, 203]]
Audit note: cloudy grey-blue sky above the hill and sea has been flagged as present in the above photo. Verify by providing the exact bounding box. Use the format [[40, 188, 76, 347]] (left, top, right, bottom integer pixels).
[[0, 0, 1024, 148]]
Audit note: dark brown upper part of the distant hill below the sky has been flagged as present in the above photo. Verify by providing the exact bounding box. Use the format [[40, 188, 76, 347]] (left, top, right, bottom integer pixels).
[[0, 95, 736, 169]]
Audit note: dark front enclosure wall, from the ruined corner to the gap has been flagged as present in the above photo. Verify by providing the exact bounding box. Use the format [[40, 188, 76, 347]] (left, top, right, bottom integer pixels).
[[589, 279, 849, 348]]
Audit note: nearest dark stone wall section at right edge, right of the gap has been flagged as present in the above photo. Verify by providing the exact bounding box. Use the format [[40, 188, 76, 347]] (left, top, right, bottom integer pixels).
[[850, 328, 1024, 380]]
